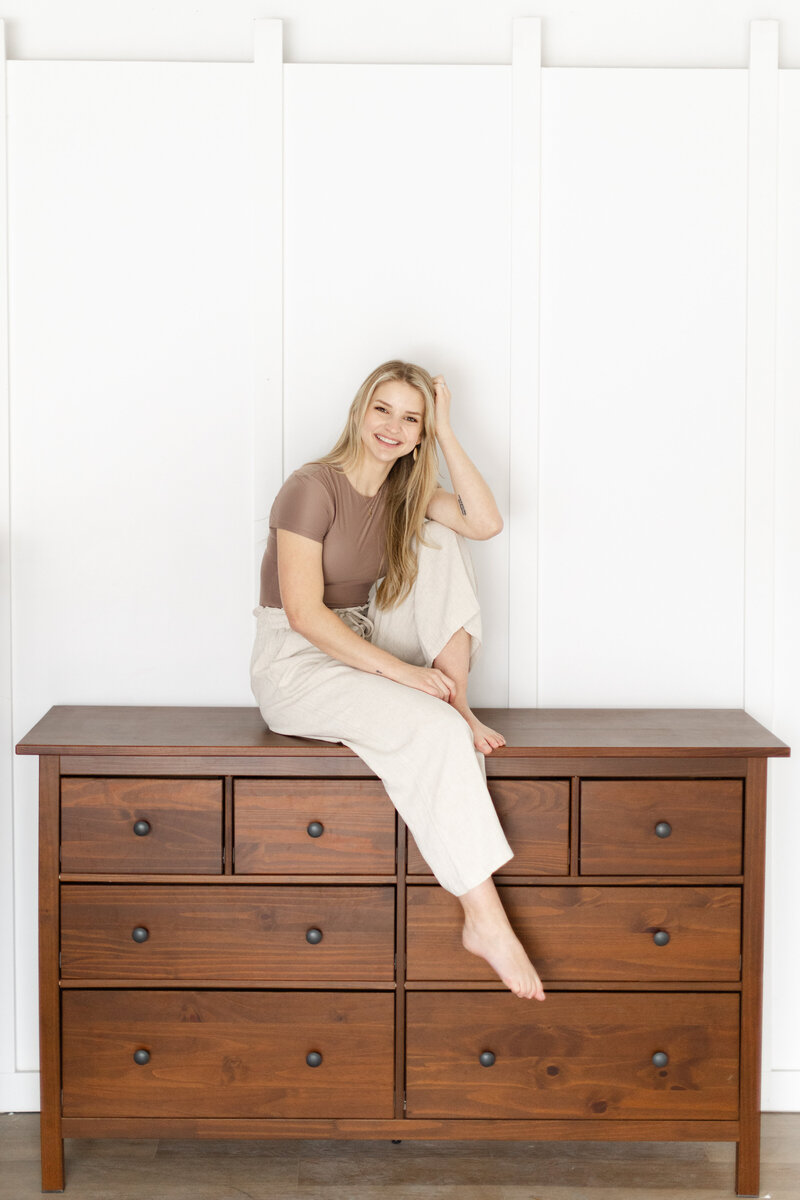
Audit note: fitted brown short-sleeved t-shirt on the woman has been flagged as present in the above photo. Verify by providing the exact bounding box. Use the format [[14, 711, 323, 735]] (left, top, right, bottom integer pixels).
[[260, 462, 386, 608]]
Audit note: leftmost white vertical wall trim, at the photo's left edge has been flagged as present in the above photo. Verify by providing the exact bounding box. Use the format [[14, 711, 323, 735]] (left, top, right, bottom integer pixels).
[[0, 20, 17, 1094]]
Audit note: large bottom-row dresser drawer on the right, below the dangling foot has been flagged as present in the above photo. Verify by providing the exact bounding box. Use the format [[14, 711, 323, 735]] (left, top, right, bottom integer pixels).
[[405, 992, 739, 1118]]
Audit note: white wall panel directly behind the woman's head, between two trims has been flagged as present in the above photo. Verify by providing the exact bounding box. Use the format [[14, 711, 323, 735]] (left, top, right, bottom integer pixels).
[[283, 66, 511, 706]]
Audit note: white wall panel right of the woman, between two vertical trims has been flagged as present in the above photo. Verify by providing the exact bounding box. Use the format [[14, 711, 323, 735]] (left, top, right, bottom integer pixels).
[[539, 70, 747, 708]]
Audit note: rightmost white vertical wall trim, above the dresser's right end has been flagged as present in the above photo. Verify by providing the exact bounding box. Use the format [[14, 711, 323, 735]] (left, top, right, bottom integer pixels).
[[742, 20, 778, 726]]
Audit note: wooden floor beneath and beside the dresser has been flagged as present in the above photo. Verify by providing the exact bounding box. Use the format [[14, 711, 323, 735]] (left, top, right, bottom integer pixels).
[[0, 1112, 800, 1200]]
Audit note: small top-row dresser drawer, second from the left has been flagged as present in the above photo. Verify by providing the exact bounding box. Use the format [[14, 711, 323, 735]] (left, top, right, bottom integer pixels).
[[234, 779, 396, 875]]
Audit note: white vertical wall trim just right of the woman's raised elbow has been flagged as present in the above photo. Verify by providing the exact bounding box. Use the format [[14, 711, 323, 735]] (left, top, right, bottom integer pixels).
[[509, 17, 542, 708]]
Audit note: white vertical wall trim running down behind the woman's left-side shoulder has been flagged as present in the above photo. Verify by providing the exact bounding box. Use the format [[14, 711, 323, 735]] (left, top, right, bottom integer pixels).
[[253, 19, 283, 604]]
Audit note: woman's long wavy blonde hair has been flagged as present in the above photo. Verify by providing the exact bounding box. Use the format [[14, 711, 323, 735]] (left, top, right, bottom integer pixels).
[[313, 359, 439, 608]]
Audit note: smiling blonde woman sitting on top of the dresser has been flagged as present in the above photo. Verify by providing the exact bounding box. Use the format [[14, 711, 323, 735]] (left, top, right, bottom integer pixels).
[[251, 361, 545, 1000]]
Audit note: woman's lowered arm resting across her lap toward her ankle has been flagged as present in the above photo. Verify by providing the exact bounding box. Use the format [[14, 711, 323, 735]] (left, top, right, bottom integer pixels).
[[277, 529, 456, 701]]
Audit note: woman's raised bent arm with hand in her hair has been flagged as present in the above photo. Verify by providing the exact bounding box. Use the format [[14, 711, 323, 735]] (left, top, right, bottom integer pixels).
[[425, 376, 503, 541]]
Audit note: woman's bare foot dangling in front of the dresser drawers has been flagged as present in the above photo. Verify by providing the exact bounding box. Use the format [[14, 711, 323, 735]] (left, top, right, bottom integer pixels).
[[458, 878, 545, 1000]]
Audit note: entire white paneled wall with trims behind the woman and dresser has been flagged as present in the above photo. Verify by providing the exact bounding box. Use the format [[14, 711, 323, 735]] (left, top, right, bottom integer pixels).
[[0, 20, 800, 1109]]
